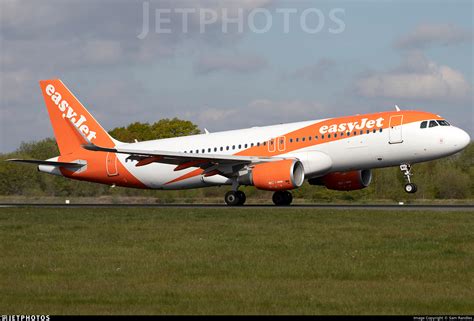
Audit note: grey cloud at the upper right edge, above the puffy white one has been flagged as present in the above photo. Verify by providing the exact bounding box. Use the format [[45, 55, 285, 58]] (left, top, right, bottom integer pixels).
[[394, 24, 473, 49]]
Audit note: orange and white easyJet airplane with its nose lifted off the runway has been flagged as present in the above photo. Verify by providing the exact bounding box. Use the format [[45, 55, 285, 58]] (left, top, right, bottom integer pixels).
[[9, 79, 471, 206]]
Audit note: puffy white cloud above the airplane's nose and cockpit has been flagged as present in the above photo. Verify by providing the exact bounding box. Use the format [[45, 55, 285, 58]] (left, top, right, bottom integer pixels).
[[355, 52, 473, 101]]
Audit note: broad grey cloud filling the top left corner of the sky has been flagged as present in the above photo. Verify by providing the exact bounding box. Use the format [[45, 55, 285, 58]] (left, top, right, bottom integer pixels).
[[0, 0, 273, 72]]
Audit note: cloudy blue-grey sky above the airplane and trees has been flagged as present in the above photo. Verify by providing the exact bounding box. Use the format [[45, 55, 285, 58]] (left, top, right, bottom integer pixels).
[[0, 0, 474, 152]]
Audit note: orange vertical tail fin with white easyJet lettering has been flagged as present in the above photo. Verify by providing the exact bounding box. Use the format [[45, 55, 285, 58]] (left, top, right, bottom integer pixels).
[[40, 79, 118, 155]]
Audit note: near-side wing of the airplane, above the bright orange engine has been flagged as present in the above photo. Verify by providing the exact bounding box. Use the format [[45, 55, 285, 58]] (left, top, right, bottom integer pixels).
[[82, 143, 285, 176]]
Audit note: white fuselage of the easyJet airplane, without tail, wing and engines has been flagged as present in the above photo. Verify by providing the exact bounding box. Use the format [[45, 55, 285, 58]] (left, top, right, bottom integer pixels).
[[112, 114, 470, 189]]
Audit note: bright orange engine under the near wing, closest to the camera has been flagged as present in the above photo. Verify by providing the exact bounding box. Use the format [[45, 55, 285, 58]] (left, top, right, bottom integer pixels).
[[238, 159, 304, 191]]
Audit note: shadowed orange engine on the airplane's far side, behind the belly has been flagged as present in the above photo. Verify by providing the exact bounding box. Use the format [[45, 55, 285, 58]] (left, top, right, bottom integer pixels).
[[308, 169, 372, 191]]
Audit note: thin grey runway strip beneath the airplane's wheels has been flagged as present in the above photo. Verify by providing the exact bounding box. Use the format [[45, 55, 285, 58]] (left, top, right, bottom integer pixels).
[[0, 203, 474, 211]]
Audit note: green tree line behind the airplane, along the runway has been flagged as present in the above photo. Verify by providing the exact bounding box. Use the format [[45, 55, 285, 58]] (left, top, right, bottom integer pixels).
[[0, 118, 474, 202]]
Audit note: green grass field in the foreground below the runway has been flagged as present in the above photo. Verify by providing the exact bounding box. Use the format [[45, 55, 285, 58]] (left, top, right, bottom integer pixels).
[[0, 208, 474, 315]]
